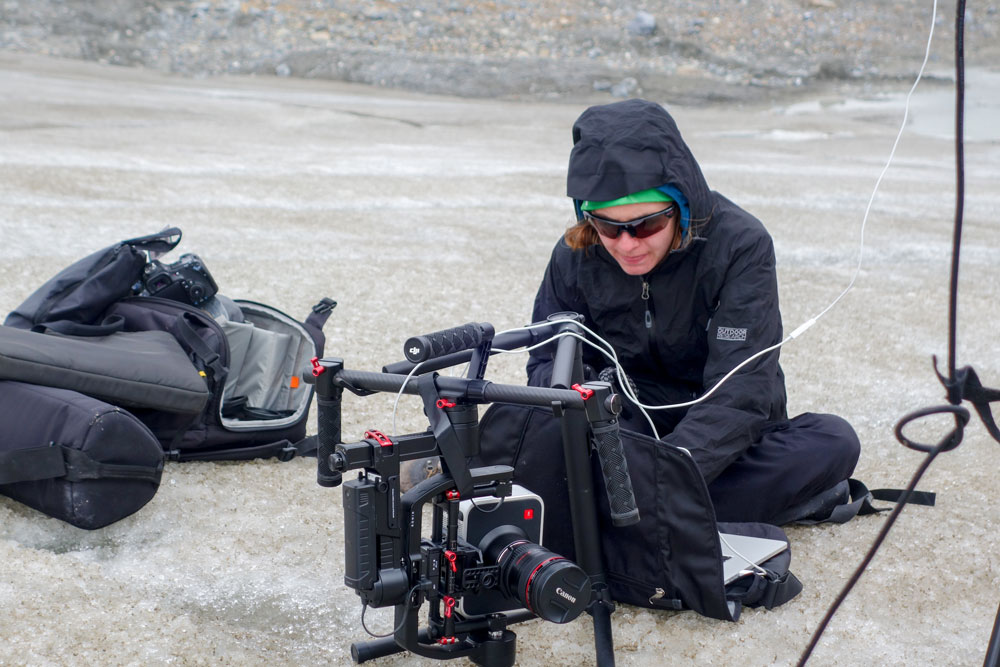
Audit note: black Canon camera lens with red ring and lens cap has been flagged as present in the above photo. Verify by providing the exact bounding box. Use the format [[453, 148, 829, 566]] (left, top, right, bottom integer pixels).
[[480, 526, 590, 623]]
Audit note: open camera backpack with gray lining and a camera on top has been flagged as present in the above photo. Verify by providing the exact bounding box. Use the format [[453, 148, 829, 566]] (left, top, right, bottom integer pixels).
[[0, 227, 336, 461]]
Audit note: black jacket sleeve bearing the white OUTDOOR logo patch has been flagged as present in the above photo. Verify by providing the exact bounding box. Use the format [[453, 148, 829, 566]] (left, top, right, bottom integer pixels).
[[663, 232, 784, 482]]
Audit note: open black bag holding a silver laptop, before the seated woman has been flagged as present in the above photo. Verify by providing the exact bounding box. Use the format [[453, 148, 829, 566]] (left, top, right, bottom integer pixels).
[[480, 404, 802, 621]]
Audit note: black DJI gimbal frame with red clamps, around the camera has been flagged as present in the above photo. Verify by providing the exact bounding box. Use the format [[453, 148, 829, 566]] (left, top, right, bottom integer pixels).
[[307, 313, 639, 667]]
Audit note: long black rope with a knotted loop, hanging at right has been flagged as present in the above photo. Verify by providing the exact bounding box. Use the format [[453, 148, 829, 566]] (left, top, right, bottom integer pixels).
[[798, 0, 968, 667]]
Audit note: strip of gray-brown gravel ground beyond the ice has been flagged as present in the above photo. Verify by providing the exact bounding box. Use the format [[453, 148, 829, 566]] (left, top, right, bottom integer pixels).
[[0, 0, 1000, 102]]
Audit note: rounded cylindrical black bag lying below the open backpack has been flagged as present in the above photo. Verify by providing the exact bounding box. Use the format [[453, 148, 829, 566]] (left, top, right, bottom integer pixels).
[[0, 381, 163, 529]]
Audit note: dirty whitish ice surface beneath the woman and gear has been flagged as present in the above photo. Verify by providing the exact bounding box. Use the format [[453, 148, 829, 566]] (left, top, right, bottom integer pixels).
[[0, 57, 1000, 665]]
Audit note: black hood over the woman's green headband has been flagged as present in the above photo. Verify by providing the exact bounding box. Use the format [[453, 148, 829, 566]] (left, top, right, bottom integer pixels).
[[566, 100, 712, 235]]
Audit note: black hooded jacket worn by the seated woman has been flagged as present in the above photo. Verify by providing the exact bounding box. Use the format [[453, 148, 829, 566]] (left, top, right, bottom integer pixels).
[[528, 100, 787, 482]]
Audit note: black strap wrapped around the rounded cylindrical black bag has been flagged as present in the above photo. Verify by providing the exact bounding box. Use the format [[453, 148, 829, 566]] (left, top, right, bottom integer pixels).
[[0, 445, 163, 484]]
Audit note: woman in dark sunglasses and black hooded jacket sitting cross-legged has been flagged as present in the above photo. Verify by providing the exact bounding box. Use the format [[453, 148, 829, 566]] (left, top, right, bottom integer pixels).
[[528, 100, 860, 523]]
